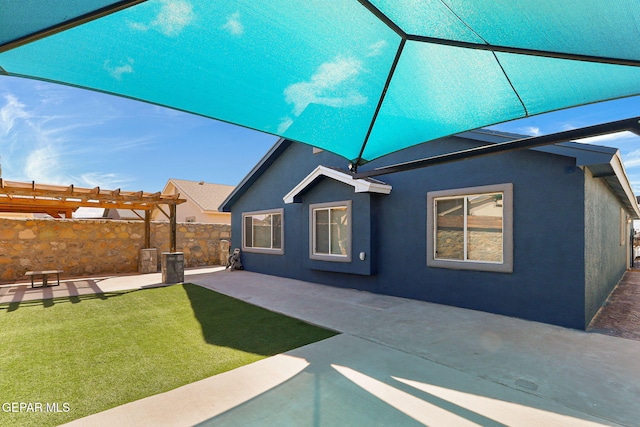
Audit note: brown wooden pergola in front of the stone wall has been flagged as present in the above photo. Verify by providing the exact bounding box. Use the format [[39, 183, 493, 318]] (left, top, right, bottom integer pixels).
[[0, 178, 186, 252]]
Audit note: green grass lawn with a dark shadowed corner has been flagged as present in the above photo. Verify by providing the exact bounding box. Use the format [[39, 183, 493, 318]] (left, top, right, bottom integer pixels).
[[0, 284, 335, 426]]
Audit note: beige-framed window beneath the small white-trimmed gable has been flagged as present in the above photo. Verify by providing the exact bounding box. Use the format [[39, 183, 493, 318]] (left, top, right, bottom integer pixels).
[[309, 200, 351, 262]]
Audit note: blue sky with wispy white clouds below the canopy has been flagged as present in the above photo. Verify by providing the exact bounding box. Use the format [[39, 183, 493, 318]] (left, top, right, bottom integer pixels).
[[0, 76, 640, 201]]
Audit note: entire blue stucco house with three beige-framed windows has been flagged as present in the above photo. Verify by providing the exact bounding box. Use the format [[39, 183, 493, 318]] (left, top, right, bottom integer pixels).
[[221, 130, 640, 329]]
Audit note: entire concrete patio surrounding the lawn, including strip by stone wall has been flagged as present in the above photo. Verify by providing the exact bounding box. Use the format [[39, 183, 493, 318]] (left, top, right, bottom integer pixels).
[[0, 268, 640, 426]]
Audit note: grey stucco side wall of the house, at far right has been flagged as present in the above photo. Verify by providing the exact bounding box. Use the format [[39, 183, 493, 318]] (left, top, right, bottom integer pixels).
[[584, 170, 629, 327]]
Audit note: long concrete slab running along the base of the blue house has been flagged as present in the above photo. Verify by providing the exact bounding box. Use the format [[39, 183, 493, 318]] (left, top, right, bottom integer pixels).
[[196, 272, 640, 425]]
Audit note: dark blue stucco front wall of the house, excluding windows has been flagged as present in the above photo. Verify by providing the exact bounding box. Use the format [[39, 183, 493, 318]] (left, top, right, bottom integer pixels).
[[232, 138, 585, 328]]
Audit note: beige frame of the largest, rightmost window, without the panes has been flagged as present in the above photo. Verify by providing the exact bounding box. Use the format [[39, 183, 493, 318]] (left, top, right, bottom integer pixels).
[[427, 183, 513, 273]]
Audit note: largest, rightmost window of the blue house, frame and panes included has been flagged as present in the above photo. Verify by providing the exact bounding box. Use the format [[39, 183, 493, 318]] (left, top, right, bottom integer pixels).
[[427, 184, 513, 272]]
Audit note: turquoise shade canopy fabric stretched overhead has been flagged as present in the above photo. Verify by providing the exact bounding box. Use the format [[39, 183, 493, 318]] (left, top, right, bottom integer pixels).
[[0, 0, 640, 164]]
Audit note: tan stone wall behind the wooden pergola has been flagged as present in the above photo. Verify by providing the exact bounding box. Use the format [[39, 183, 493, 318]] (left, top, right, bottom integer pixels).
[[0, 218, 231, 281]]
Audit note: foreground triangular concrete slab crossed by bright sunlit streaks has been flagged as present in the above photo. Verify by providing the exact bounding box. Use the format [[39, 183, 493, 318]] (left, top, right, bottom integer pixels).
[[67, 335, 615, 427]]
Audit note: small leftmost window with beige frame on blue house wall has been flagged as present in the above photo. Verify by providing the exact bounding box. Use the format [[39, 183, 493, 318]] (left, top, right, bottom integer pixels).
[[242, 209, 284, 255]]
